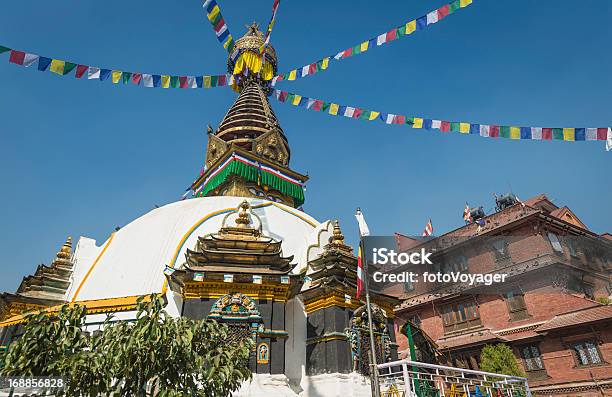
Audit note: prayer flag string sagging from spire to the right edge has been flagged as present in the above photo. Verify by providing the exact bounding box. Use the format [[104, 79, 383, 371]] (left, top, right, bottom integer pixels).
[[272, 89, 612, 142]]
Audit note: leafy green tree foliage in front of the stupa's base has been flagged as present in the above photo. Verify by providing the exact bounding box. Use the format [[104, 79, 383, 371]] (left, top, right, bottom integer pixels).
[[0, 294, 252, 397]]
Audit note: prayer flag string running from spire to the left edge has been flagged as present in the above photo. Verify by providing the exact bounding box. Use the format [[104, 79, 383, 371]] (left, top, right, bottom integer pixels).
[[0, 46, 234, 88]]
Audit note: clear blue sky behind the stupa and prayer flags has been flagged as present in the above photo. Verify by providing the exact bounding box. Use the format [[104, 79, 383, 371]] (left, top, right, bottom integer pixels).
[[0, 0, 612, 291]]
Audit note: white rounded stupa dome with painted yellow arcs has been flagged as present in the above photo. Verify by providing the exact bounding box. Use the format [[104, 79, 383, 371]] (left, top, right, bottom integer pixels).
[[67, 196, 332, 302]]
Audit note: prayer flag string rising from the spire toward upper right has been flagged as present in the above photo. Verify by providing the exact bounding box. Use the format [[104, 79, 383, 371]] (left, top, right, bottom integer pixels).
[[272, 0, 472, 86]]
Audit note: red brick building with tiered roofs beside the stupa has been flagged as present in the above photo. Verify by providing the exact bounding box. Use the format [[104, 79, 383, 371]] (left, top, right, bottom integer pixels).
[[386, 195, 612, 397]]
